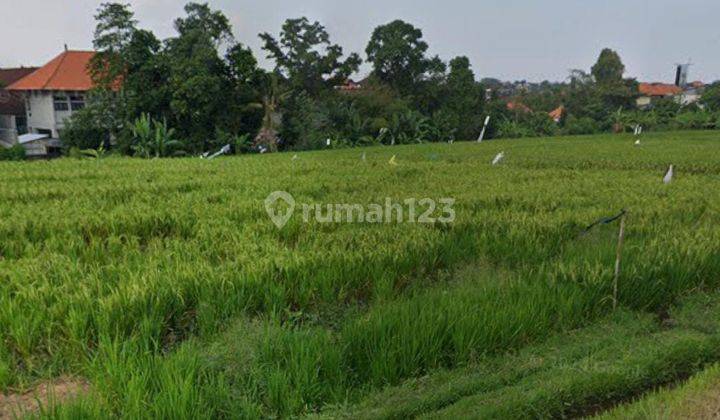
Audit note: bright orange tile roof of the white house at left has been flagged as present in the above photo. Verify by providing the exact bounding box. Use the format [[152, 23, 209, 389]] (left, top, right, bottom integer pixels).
[[8, 51, 95, 91]]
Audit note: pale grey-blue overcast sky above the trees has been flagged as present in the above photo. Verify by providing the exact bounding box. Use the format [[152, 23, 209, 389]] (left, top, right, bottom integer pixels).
[[0, 0, 720, 82]]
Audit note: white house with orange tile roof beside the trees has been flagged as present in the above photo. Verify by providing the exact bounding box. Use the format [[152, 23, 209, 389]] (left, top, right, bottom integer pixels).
[[8, 50, 95, 156]]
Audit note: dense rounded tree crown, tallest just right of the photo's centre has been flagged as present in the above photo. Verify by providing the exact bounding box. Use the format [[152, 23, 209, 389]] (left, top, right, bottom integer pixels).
[[365, 20, 437, 93]]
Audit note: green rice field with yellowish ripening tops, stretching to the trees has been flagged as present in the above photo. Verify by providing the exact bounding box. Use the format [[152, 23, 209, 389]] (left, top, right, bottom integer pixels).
[[0, 132, 720, 418]]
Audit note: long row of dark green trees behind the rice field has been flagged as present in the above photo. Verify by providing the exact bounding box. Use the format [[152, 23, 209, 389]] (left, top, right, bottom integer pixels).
[[61, 3, 720, 157]]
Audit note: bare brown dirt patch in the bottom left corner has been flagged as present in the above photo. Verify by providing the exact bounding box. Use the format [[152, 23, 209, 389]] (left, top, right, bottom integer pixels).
[[0, 377, 89, 420]]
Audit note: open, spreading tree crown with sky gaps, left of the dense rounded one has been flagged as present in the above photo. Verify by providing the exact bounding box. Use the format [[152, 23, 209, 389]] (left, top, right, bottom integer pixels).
[[260, 17, 362, 96]]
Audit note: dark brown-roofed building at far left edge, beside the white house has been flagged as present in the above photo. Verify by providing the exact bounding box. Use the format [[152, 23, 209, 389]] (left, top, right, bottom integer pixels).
[[0, 67, 37, 147]]
